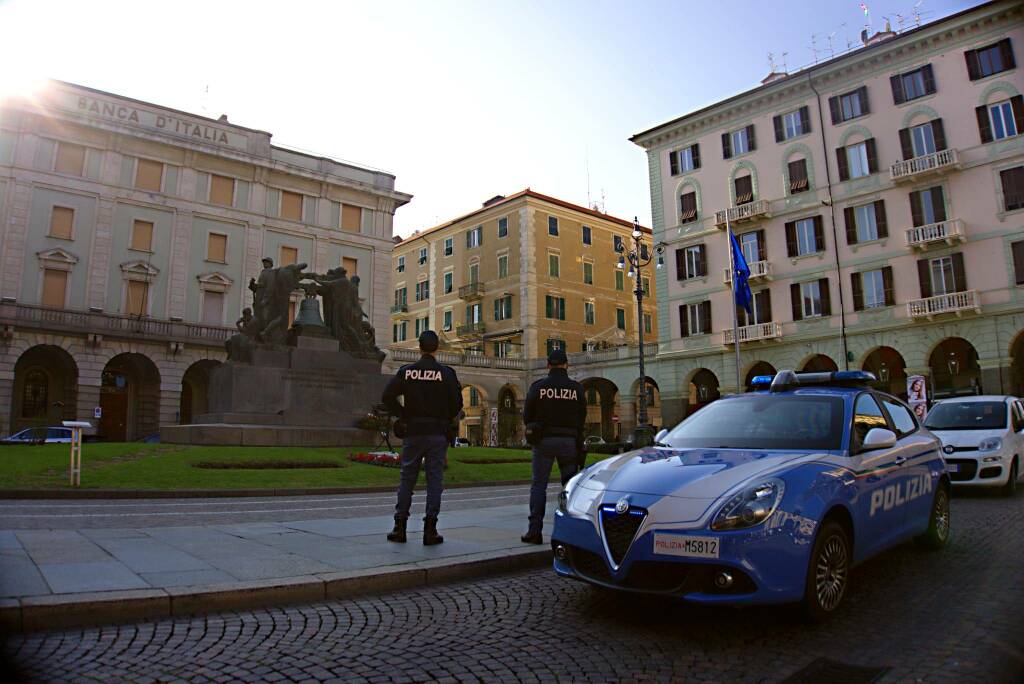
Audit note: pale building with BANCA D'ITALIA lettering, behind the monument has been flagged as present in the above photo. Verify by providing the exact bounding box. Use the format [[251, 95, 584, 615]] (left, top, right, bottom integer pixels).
[[0, 82, 411, 440]]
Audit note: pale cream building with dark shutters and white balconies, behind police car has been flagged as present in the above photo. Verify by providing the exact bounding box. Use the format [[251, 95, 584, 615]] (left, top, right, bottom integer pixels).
[[632, 2, 1024, 422]]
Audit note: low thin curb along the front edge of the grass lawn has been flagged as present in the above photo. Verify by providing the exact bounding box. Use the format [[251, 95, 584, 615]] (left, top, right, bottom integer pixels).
[[0, 480, 530, 500]]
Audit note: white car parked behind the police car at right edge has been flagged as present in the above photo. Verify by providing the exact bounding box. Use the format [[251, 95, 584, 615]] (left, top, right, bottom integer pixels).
[[925, 396, 1024, 497]]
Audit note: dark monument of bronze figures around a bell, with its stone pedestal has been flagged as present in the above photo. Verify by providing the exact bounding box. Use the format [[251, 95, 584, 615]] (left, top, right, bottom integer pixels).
[[160, 258, 387, 446]]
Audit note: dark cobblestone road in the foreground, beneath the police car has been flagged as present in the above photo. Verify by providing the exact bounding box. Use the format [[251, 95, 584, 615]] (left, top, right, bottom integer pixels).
[[4, 495, 1024, 683]]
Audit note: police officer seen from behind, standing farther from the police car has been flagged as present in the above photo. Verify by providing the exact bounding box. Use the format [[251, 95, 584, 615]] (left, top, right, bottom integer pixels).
[[381, 330, 462, 546]]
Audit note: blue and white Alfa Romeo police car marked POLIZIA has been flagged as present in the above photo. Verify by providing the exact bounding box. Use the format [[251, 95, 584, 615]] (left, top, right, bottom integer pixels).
[[551, 371, 950, 621]]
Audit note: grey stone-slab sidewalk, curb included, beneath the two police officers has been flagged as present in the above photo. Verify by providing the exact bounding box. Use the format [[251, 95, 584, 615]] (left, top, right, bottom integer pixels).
[[0, 497, 554, 631]]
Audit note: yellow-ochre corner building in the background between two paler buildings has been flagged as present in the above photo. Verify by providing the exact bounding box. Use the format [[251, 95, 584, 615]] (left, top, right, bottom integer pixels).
[[391, 188, 657, 360]]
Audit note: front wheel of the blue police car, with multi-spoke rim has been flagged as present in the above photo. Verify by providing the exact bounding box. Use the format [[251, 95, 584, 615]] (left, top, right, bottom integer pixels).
[[803, 520, 853, 623]]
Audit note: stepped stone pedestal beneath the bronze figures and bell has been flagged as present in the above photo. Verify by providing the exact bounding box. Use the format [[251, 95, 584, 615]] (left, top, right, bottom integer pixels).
[[160, 333, 388, 446]]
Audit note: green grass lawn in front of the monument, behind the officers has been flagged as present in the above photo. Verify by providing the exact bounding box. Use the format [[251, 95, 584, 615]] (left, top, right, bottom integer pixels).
[[0, 442, 607, 489]]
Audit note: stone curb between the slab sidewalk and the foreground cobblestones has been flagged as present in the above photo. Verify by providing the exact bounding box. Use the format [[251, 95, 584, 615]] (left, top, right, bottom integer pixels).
[[0, 548, 552, 634]]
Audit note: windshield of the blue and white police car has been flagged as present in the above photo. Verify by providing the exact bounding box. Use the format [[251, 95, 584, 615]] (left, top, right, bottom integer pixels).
[[663, 394, 845, 451]]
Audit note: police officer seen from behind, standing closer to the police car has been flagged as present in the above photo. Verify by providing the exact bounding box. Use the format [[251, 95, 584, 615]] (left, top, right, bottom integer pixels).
[[521, 349, 587, 544]]
